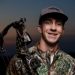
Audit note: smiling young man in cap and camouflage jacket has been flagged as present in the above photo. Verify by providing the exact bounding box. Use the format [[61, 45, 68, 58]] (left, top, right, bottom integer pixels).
[[6, 7, 75, 75]]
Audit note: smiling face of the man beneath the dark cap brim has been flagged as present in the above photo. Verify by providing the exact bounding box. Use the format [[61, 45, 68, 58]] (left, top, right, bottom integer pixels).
[[39, 18, 64, 44]]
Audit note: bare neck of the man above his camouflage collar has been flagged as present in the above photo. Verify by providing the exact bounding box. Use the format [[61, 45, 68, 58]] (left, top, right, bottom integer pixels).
[[38, 39, 58, 53]]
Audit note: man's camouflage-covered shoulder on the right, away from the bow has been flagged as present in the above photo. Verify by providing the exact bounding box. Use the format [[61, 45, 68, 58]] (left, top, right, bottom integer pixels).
[[55, 50, 75, 75]]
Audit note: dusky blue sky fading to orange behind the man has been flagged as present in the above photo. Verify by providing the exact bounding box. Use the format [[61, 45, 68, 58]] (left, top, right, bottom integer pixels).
[[0, 0, 75, 55]]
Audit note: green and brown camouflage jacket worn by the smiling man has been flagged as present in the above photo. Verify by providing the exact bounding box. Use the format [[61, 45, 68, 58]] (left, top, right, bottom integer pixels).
[[6, 46, 75, 75]]
